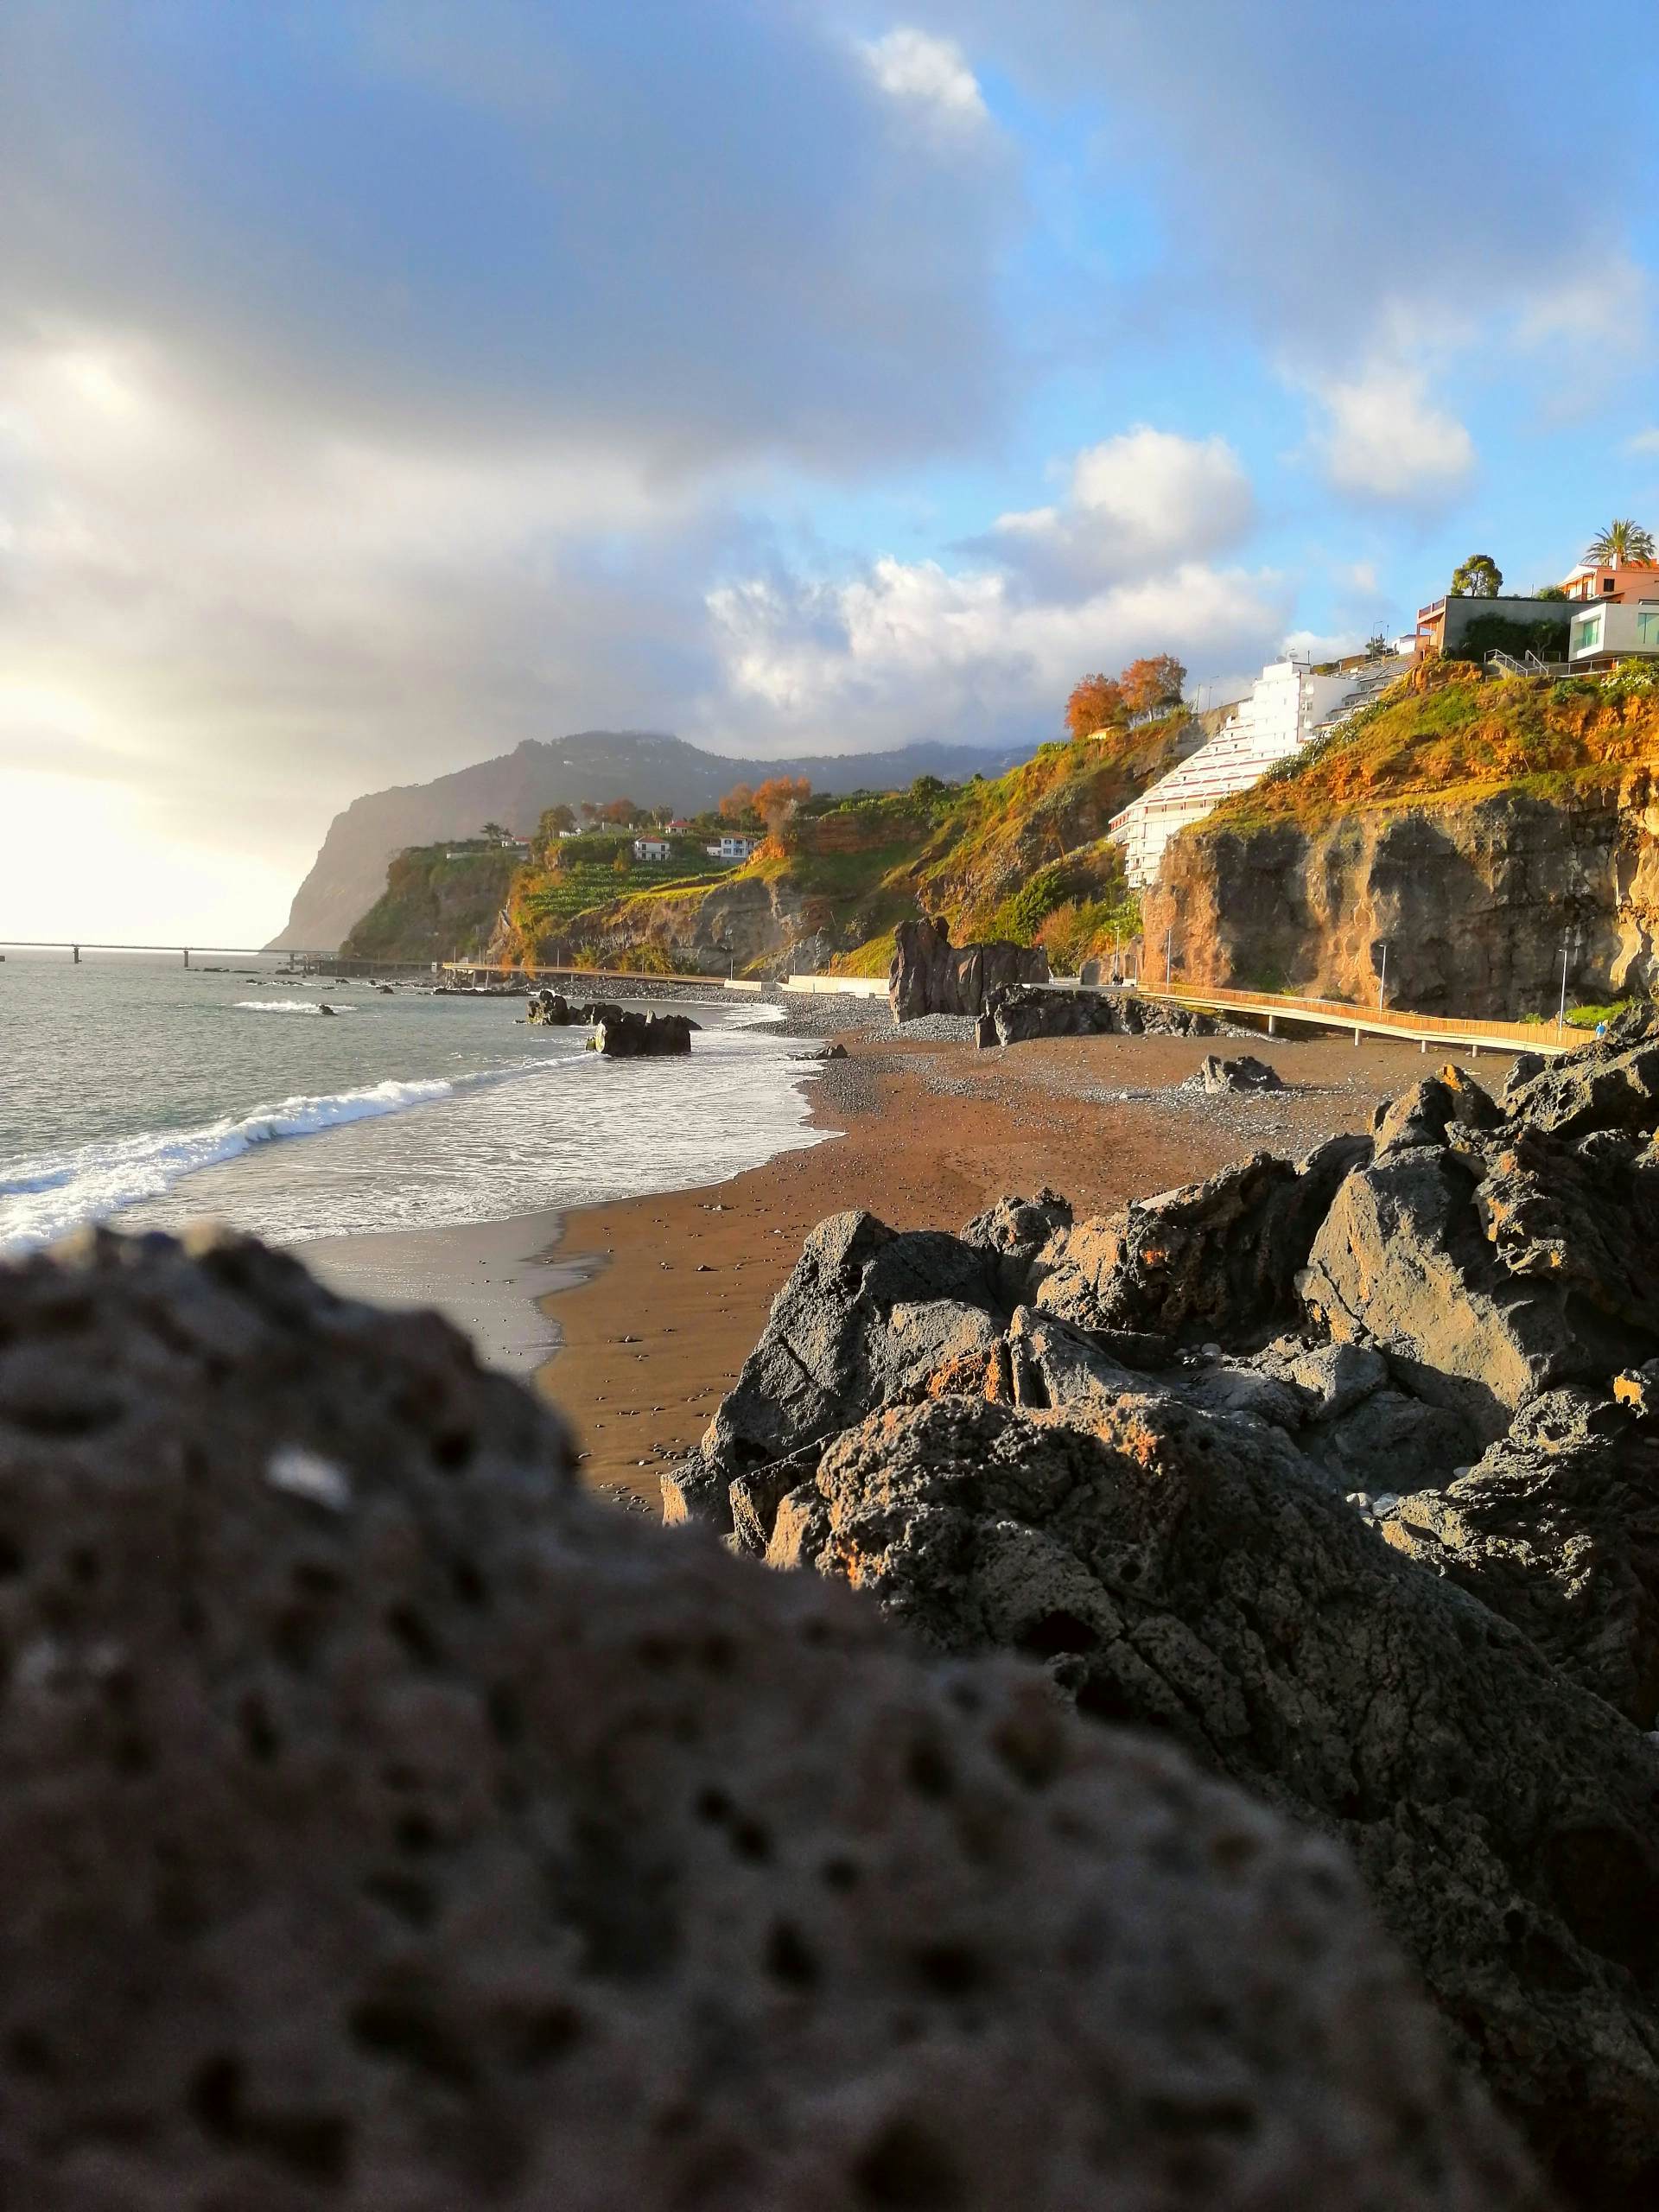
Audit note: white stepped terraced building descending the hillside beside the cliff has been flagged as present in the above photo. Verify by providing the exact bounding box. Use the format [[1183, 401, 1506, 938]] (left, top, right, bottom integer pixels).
[[1106, 655, 1411, 889]]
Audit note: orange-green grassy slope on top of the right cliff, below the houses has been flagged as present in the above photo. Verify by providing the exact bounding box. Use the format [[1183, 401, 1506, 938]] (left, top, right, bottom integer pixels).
[[1185, 661, 1659, 836]]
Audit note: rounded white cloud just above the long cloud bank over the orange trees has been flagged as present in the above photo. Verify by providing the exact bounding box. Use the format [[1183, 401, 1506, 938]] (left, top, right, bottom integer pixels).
[[987, 423, 1256, 591]]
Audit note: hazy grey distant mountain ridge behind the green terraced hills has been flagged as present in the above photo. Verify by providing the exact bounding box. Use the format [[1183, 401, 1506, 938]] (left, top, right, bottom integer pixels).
[[270, 730, 1020, 951]]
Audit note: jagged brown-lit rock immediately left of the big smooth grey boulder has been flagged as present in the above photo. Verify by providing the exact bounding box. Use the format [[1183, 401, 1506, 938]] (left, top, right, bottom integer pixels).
[[1035, 1137, 1371, 1343]]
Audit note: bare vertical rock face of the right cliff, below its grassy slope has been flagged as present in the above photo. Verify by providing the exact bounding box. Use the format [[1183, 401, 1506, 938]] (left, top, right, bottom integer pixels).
[[1146, 767, 1659, 1020]]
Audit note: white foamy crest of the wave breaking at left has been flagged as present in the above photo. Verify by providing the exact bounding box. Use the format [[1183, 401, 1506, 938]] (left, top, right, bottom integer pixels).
[[0, 1077, 457, 1252]]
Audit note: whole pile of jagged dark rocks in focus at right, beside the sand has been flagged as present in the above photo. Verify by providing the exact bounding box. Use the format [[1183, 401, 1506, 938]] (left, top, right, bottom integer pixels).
[[664, 1020, 1659, 2212]]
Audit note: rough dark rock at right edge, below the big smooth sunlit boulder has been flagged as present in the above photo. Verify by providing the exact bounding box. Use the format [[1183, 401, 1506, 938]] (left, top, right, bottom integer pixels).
[[1378, 1389, 1659, 1730]]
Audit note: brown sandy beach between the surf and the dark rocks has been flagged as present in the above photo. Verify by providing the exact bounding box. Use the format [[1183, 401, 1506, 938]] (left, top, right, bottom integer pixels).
[[526, 1013, 1478, 1509]]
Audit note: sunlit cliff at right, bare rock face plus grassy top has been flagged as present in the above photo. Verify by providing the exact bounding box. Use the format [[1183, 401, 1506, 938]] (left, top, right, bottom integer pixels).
[[1144, 671, 1659, 1018]]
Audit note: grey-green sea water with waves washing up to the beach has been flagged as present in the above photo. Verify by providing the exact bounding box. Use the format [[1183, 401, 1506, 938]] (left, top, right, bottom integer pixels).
[[0, 951, 818, 1255]]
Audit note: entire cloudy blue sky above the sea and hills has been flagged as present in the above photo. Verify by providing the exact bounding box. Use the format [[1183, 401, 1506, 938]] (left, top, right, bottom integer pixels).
[[0, 0, 1659, 940]]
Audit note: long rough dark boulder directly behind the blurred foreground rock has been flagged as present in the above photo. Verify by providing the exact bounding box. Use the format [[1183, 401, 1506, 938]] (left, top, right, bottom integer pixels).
[[772, 1394, 1659, 2212]]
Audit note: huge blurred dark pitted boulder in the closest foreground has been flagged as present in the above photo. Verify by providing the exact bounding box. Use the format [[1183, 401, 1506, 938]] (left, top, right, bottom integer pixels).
[[0, 1236, 1548, 2212]]
